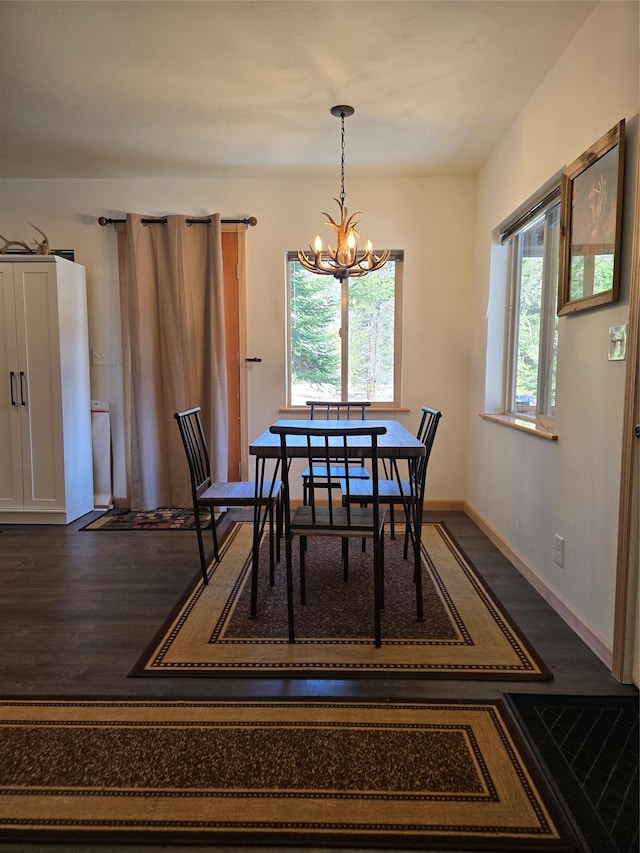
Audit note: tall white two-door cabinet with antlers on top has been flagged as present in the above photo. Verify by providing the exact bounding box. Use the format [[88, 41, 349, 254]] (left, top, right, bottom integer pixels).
[[0, 255, 93, 524]]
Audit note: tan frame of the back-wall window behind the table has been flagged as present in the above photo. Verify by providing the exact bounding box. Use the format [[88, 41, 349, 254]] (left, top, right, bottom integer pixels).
[[285, 249, 404, 410]]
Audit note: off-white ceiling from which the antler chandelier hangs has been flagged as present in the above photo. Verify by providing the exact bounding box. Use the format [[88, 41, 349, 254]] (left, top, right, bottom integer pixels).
[[0, 0, 597, 178]]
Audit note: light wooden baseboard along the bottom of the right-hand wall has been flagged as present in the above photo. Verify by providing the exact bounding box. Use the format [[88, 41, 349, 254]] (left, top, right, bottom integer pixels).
[[464, 501, 613, 671]]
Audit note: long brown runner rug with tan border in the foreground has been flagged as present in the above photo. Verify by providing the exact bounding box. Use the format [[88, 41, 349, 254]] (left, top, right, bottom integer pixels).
[[0, 699, 576, 851]]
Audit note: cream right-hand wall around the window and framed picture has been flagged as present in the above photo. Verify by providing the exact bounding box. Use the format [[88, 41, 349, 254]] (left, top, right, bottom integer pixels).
[[467, 2, 640, 654]]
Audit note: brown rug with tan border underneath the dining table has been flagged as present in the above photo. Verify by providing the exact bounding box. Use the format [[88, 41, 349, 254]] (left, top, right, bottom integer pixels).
[[131, 522, 550, 679]]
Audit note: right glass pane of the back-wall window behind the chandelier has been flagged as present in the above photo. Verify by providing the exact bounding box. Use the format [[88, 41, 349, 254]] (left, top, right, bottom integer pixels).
[[348, 260, 395, 402]]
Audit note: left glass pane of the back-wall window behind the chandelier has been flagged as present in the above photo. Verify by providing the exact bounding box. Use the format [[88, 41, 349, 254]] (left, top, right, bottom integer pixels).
[[289, 261, 341, 406]]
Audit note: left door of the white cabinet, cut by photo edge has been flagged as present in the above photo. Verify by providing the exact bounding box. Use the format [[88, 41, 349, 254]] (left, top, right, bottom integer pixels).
[[0, 264, 22, 509]]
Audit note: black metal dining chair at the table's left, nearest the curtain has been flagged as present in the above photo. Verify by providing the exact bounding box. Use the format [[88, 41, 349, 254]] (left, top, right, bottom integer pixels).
[[174, 406, 282, 604]]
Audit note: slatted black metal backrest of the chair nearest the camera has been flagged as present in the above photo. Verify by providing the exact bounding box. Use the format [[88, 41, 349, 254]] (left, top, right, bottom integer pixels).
[[270, 424, 387, 527]]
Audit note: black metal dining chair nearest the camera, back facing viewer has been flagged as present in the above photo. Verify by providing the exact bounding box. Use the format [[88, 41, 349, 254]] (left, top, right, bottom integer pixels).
[[270, 422, 387, 648]]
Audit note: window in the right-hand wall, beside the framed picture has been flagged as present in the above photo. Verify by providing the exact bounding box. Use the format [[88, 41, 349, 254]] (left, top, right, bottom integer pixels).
[[503, 190, 560, 419]]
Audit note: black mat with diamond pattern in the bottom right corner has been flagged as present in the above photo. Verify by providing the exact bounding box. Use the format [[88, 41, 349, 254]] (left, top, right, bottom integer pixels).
[[507, 693, 640, 853]]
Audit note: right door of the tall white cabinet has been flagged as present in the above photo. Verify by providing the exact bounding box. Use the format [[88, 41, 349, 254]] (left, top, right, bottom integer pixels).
[[14, 264, 64, 510]]
